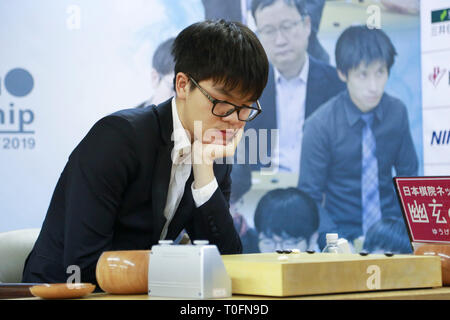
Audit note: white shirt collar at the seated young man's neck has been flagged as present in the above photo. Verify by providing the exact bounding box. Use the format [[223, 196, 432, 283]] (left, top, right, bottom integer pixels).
[[172, 97, 191, 164]]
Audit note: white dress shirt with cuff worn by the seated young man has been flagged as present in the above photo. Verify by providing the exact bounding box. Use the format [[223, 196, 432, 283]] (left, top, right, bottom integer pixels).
[[160, 97, 218, 239]]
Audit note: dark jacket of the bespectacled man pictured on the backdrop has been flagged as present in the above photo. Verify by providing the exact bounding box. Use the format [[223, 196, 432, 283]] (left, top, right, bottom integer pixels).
[[241, 56, 345, 170]]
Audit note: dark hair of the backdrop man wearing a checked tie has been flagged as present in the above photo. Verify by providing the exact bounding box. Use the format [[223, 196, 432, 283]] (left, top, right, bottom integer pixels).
[[335, 26, 397, 75]]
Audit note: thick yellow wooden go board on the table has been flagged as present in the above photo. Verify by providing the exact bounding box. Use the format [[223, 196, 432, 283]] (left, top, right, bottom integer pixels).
[[222, 252, 442, 297]]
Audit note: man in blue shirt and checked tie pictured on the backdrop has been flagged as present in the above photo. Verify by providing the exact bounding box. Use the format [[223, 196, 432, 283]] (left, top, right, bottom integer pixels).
[[298, 25, 419, 249]]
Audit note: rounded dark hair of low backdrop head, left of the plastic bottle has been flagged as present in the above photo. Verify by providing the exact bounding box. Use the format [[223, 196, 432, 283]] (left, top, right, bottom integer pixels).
[[254, 187, 319, 240]]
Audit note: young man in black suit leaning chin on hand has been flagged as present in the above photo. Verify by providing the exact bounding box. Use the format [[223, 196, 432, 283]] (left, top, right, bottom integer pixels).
[[23, 20, 268, 283]]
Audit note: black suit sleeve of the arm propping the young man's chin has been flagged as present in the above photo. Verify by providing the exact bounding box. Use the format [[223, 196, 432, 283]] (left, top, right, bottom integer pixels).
[[186, 165, 242, 254]]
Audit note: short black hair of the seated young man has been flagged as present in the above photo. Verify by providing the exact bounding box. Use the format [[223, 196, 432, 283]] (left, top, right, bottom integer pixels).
[[172, 19, 269, 100]]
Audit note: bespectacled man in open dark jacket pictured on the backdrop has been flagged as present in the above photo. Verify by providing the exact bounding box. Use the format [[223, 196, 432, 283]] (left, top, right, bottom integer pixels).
[[246, 0, 344, 174]]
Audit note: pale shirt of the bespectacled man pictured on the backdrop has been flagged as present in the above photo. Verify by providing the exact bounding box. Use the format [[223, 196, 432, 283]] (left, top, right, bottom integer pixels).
[[272, 56, 309, 173]]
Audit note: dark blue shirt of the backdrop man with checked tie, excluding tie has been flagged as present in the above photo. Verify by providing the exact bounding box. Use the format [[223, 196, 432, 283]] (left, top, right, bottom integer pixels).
[[298, 90, 418, 249]]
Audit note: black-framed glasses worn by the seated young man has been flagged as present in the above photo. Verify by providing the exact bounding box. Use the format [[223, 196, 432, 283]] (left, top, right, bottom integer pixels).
[[188, 75, 262, 122]]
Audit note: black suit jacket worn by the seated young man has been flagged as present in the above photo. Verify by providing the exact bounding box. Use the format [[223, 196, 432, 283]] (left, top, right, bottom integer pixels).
[[23, 100, 242, 283]]
